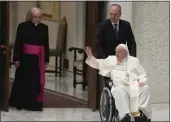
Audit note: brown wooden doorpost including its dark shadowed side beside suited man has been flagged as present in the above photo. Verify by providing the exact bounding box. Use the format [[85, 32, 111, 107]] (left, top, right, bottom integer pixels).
[[84, 1, 107, 111]]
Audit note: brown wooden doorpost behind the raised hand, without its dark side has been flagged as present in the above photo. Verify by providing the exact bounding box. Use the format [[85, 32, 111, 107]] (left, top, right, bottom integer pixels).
[[84, 1, 99, 111]]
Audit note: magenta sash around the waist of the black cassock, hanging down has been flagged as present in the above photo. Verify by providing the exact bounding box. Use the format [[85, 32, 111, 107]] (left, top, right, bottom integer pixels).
[[24, 44, 45, 102]]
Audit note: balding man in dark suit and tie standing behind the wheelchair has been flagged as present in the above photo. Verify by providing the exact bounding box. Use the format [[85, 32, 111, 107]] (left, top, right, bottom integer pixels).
[[97, 4, 136, 58]]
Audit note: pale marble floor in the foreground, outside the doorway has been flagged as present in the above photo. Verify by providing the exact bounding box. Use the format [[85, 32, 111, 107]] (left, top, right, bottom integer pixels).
[[1, 104, 169, 122]]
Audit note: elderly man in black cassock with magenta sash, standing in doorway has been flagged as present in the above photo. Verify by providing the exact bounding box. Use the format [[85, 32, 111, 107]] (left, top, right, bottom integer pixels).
[[9, 8, 49, 111]]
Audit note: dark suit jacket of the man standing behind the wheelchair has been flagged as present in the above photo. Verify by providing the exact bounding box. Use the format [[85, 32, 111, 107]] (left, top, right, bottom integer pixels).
[[96, 19, 136, 58]]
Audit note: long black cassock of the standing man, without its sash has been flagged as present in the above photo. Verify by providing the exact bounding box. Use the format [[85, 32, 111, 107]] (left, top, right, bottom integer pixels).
[[9, 21, 49, 110]]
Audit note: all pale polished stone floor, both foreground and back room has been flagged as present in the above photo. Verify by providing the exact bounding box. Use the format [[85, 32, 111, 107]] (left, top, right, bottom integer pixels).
[[7, 67, 169, 121]]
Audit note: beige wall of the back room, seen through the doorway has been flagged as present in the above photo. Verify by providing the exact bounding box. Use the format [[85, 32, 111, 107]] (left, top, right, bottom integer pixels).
[[10, 1, 84, 70]]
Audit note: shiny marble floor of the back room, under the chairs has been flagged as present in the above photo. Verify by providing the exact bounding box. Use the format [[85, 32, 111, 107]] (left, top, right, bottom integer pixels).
[[9, 66, 88, 101]]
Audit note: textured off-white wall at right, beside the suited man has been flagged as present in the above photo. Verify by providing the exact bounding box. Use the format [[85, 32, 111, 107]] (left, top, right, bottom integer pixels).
[[133, 2, 170, 103]]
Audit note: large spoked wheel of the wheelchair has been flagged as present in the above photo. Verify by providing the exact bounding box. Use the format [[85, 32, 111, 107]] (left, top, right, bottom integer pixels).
[[100, 87, 113, 122]]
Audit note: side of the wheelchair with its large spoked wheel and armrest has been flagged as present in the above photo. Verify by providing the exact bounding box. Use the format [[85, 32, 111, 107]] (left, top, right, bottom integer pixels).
[[100, 77, 119, 122]]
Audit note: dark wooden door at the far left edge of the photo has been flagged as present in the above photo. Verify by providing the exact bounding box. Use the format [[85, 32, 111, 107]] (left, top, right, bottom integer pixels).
[[0, 1, 9, 111]]
